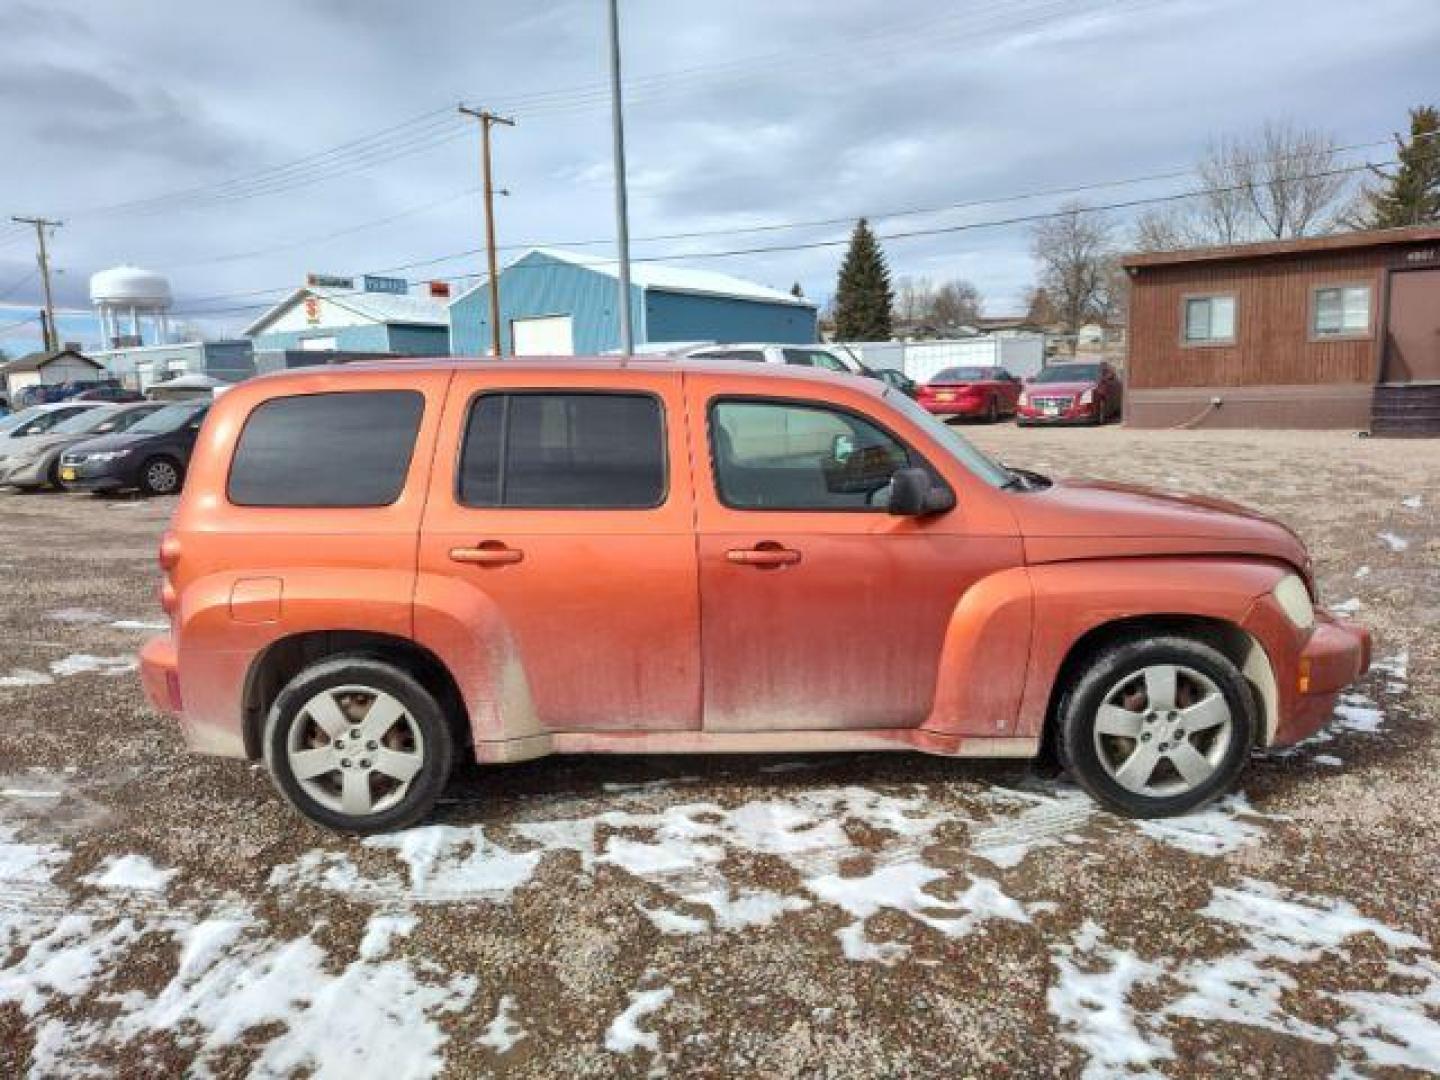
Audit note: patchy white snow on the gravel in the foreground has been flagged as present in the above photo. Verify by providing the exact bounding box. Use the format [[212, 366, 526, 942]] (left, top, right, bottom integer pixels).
[[0, 654, 1440, 1077]]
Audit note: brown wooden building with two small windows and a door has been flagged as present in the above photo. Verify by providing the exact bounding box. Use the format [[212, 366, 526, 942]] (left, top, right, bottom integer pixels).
[[1122, 228, 1440, 435]]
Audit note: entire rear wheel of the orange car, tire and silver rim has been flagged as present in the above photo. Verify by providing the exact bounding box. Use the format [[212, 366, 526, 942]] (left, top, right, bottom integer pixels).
[[264, 657, 454, 834]]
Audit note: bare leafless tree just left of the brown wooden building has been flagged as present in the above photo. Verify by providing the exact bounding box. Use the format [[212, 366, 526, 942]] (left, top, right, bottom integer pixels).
[[1031, 203, 1115, 348]]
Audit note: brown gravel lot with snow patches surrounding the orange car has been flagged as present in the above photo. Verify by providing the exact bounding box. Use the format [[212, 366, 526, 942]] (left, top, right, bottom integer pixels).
[[0, 426, 1440, 1080]]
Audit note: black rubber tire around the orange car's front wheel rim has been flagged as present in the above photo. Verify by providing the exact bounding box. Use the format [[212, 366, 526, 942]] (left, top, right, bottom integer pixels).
[[1058, 635, 1259, 818]]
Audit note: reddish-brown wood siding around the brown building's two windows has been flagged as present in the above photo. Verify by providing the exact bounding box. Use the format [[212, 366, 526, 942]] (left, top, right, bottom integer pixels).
[[1126, 249, 1397, 389]]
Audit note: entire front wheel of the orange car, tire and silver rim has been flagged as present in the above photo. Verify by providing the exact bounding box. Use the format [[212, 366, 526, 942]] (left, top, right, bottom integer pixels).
[[1060, 635, 1259, 818]]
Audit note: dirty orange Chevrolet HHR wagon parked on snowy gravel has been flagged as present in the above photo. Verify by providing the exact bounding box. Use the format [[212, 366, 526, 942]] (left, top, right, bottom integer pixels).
[[143, 360, 1369, 832]]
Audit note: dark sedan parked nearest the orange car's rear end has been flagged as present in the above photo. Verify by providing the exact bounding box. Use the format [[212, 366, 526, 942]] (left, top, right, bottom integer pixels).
[[60, 400, 210, 495]]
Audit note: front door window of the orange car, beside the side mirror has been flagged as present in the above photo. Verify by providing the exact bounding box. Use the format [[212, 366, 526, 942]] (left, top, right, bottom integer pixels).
[[710, 400, 910, 510]]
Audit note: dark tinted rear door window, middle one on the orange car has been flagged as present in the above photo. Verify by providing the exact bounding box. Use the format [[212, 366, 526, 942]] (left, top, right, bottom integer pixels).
[[458, 393, 665, 510]]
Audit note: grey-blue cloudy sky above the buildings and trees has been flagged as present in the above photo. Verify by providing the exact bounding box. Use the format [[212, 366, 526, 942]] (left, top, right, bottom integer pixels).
[[0, 0, 1440, 353]]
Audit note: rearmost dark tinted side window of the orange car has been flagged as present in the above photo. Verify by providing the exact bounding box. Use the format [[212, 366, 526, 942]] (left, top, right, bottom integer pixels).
[[229, 390, 425, 507]]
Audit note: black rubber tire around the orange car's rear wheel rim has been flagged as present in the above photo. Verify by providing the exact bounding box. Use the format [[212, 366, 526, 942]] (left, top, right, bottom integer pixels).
[[264, 657, 455, 835]]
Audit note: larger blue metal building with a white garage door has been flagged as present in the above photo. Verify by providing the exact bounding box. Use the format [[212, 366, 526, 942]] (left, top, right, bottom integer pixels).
[[449, 248, 816, 356]]
